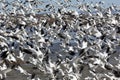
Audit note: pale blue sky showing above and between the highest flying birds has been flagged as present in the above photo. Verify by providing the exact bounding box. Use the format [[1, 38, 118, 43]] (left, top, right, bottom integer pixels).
[[0, 0, 120, 13]]
